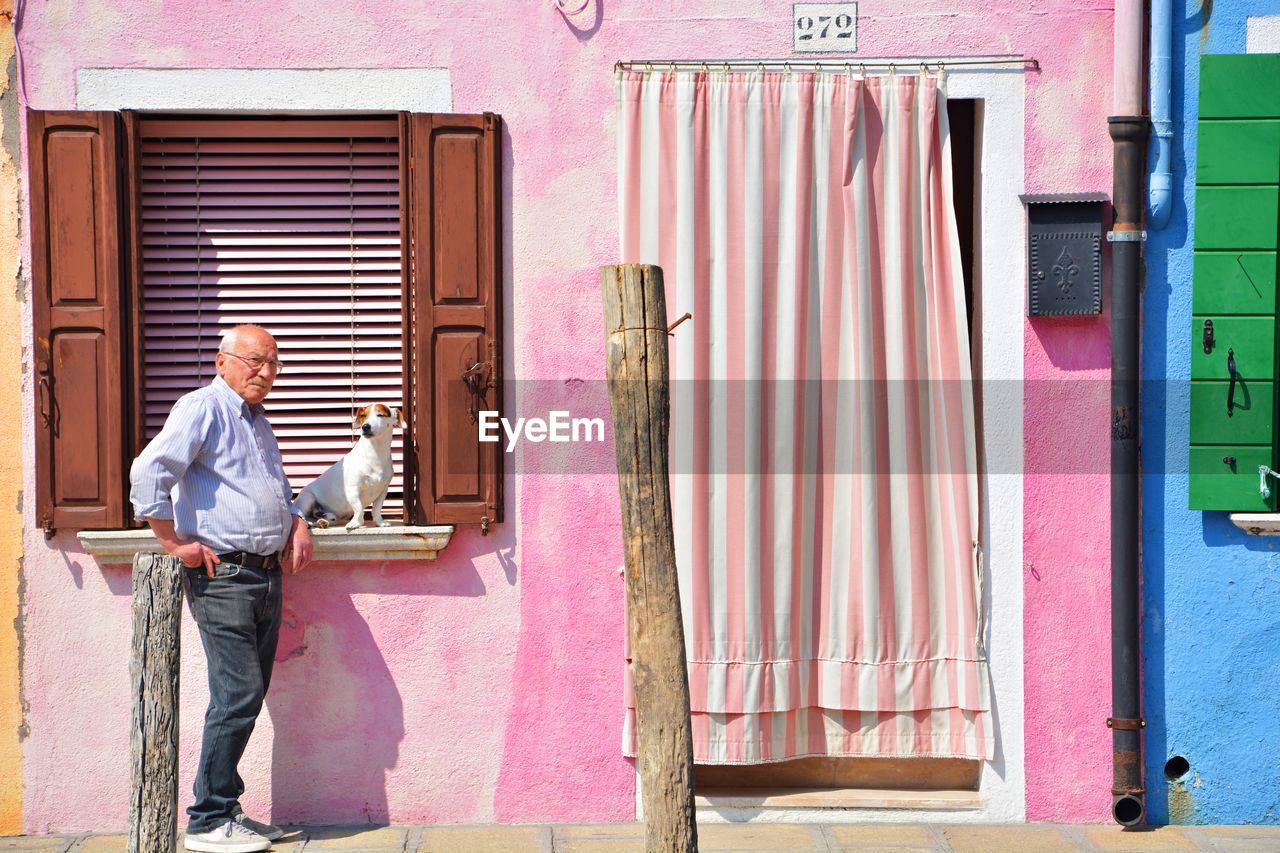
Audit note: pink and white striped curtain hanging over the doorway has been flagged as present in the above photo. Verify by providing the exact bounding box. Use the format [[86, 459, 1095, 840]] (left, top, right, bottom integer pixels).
[[618, 70, 992, 763]]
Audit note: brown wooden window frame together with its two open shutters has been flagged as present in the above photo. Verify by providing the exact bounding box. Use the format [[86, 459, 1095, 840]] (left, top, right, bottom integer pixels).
[[27, 110, 506, 537]]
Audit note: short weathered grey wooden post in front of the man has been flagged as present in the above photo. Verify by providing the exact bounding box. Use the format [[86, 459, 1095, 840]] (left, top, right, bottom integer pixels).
[[129, 553, 182, 853]]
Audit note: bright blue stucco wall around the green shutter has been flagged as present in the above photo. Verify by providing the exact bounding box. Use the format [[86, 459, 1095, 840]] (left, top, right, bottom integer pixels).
[[1142, 0, 1280, 824]]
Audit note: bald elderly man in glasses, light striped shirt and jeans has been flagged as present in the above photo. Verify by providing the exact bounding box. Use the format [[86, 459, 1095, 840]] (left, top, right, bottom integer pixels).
[[129, 325, 311, 853]]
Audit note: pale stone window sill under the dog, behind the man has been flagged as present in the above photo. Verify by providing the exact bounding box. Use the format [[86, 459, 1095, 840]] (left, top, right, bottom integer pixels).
[[76, 523, 453, 564]]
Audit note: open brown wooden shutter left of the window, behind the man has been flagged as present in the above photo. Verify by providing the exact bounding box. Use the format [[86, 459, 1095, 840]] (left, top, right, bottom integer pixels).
[[27, 111, 125, 533]]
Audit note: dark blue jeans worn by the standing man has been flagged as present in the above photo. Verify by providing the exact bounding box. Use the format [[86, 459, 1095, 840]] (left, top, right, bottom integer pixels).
[[183, 562, 280, 834]]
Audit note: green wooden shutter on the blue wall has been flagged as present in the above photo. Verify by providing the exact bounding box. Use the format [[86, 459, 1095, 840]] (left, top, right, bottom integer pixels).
[[1189, 54, 1280, 512]]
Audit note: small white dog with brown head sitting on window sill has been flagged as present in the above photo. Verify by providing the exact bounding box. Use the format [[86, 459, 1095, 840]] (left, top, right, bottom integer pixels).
[[294, 403, 406, 530]]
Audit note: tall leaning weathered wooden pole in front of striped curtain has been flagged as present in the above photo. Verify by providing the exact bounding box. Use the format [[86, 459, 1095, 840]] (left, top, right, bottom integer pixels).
[[600, 264, 698, 853]]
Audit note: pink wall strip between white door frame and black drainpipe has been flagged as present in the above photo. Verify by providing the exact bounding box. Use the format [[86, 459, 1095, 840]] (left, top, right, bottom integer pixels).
[[1023, 4, 1112, 821]]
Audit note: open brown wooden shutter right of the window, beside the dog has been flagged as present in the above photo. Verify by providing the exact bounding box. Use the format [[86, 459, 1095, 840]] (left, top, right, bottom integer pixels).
[[404, 113, 502, 529]]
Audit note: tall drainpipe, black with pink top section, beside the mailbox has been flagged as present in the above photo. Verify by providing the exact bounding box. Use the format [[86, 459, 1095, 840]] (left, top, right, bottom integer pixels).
[[1107, 0, 1148, 826]]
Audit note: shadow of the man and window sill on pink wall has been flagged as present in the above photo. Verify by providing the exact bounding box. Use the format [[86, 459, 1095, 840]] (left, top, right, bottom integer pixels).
[[266, 525, 516, 824]]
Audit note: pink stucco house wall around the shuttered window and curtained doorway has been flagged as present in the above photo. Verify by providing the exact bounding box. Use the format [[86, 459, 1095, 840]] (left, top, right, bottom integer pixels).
[[22, 0, 1111, 833]]
